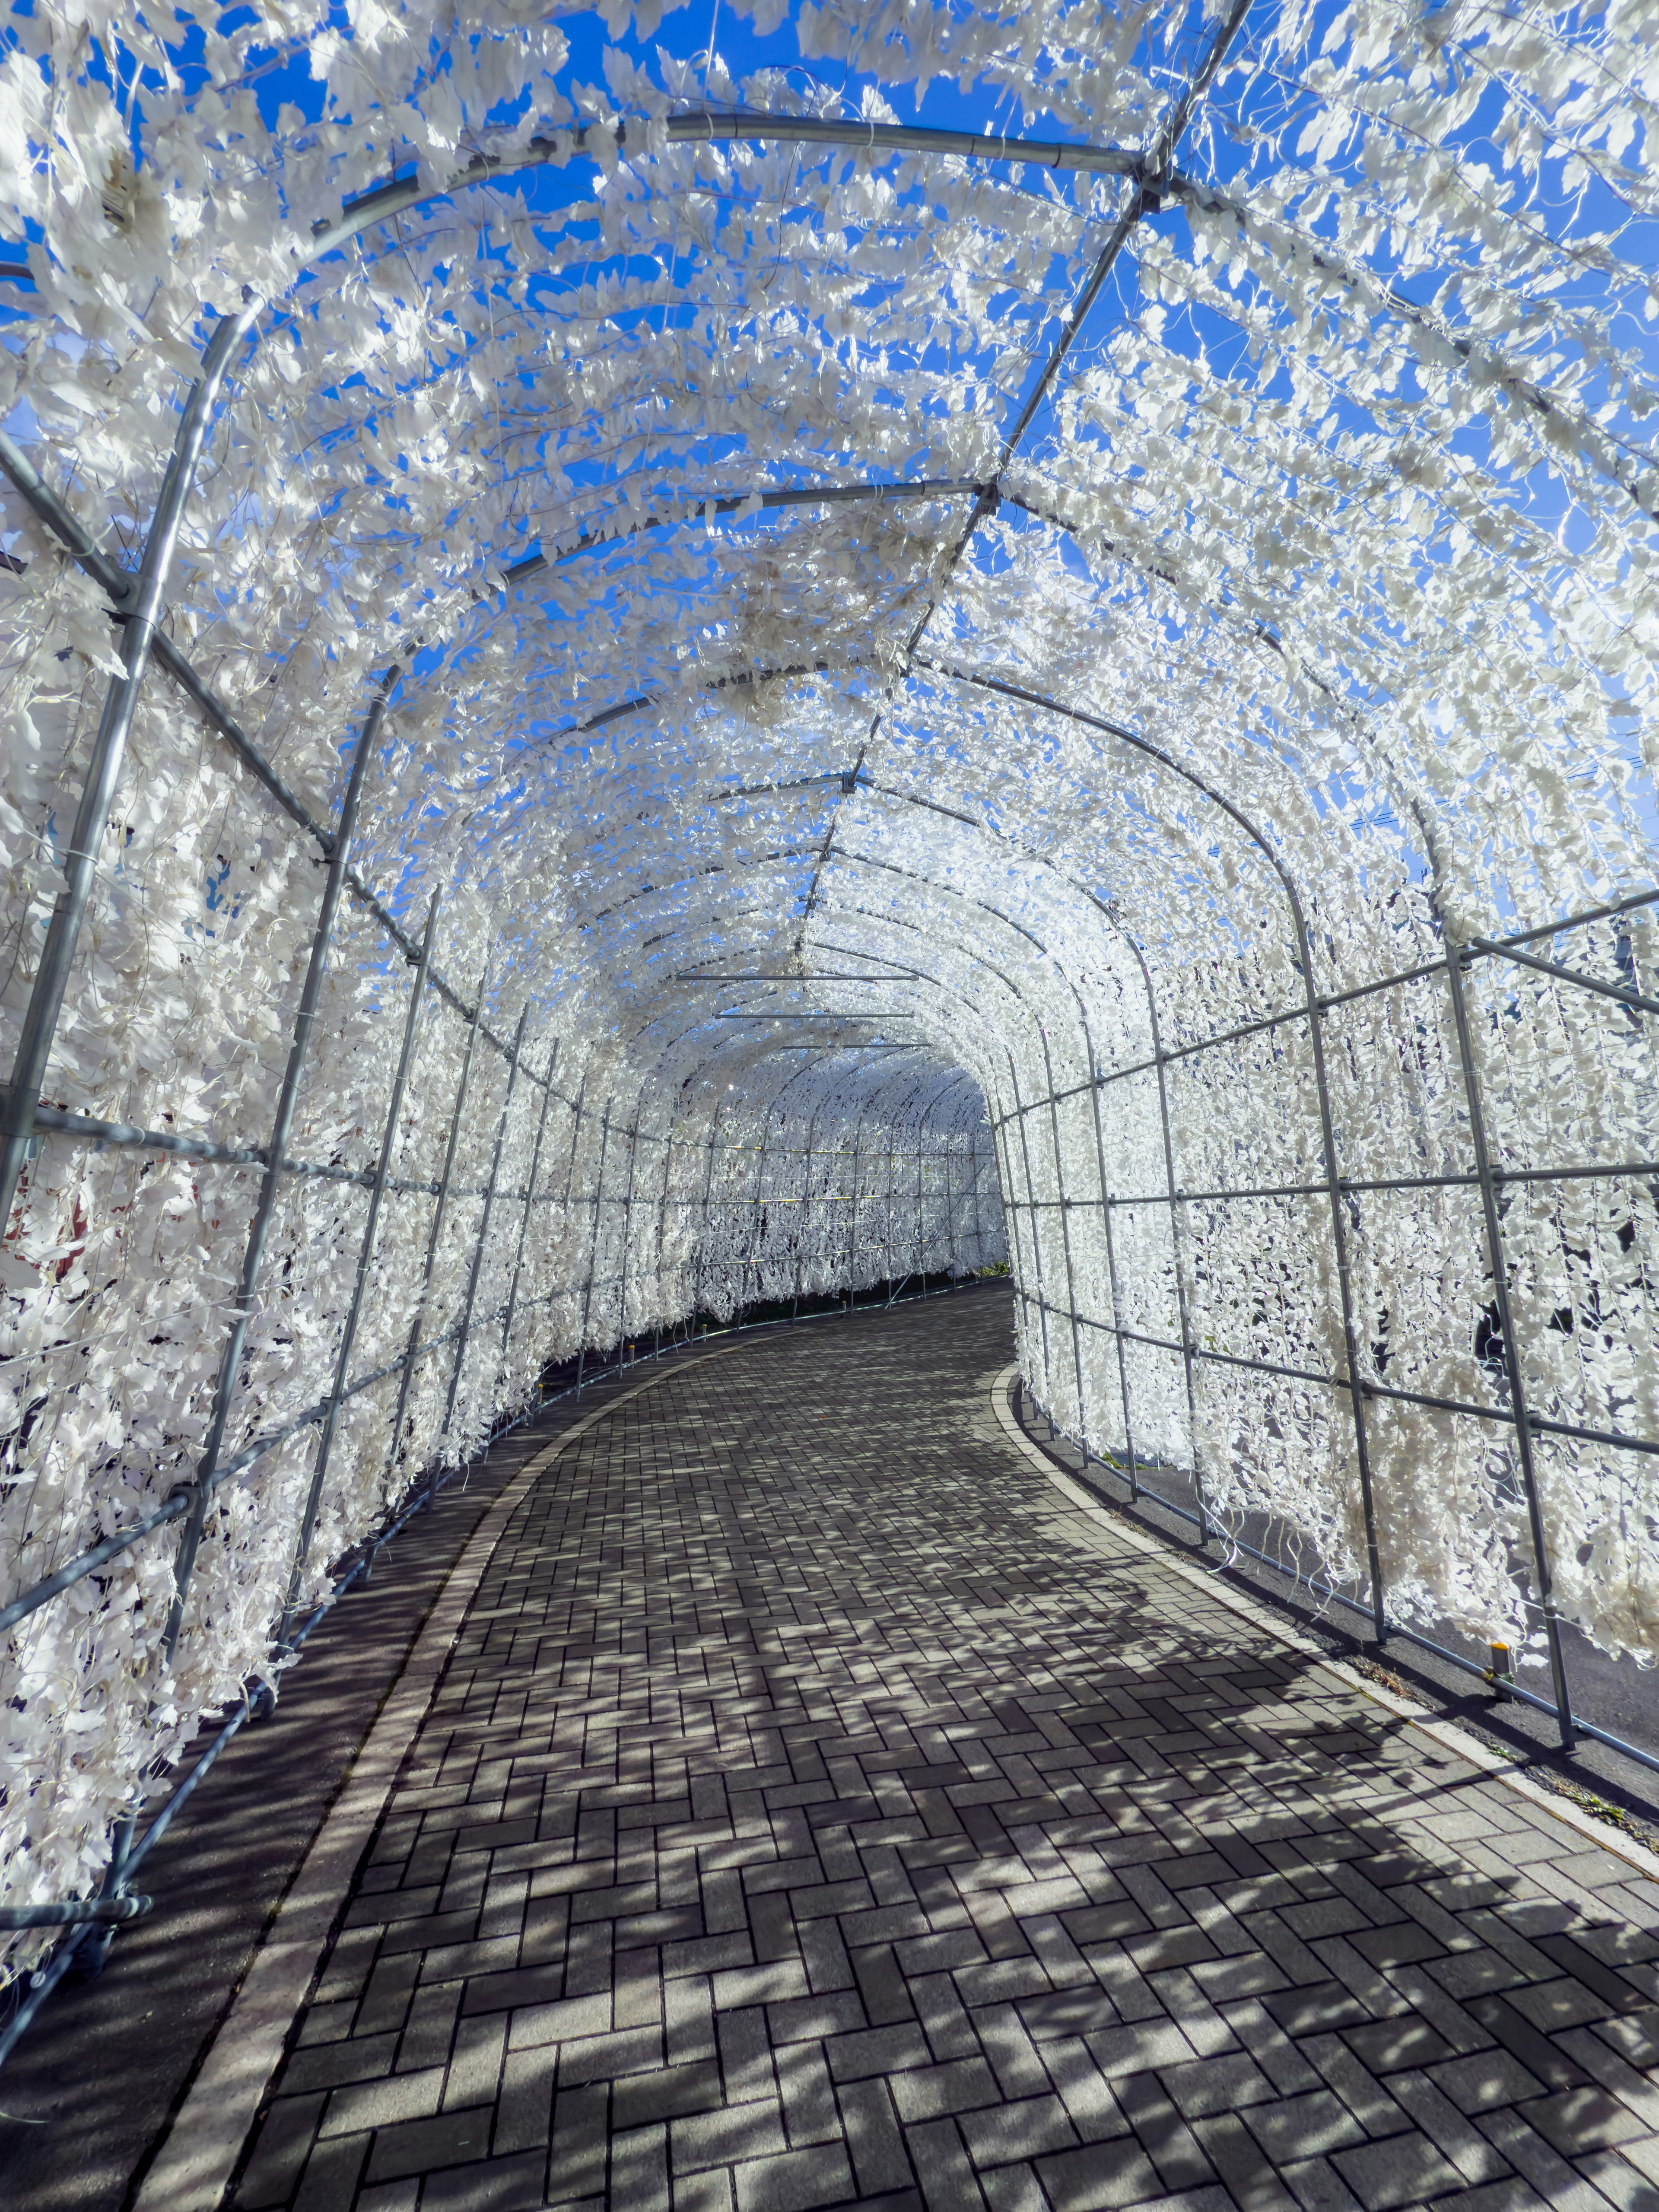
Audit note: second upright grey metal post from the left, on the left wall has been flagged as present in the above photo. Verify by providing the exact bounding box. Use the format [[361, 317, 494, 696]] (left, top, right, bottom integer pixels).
[[162, 655, 400, 1668]]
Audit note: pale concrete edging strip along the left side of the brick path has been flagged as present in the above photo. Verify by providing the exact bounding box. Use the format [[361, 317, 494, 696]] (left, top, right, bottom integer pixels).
[[133, 1345, 748, 2212]]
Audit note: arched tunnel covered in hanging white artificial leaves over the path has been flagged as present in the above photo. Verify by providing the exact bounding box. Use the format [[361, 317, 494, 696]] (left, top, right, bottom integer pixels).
[[0, 0, 1659, 2008]]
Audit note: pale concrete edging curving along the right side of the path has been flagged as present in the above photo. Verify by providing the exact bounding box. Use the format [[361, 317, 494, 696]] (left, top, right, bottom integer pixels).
[[991, 1360, 1659, 1882]]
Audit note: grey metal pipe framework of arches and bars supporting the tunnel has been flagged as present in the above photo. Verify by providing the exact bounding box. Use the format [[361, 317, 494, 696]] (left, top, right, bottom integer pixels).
[[0, 39, 1659, 2057]]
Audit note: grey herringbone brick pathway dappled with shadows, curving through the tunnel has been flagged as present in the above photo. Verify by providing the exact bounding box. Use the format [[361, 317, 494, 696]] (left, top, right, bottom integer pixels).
[[235, 1292, 1659, 2212]]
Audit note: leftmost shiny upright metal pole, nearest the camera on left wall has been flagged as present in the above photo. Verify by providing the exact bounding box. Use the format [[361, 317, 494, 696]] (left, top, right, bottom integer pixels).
[[0, 301, 260, 1247]]
